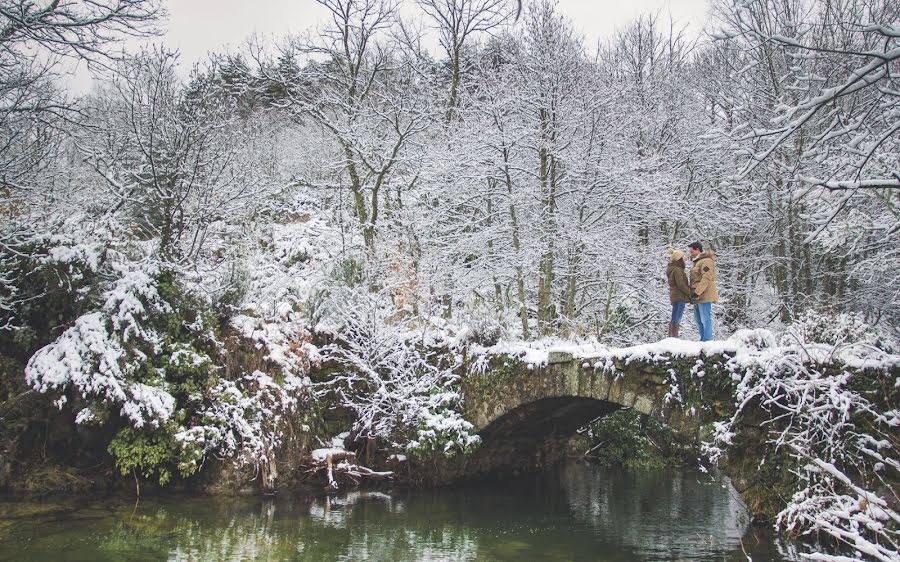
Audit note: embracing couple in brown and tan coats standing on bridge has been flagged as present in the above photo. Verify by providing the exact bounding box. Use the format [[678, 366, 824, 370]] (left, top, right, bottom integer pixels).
[[666, 242, 719, 341]]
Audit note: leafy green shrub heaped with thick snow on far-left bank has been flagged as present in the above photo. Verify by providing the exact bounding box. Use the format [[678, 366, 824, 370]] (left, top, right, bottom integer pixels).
[[25, 254, 236, 484]]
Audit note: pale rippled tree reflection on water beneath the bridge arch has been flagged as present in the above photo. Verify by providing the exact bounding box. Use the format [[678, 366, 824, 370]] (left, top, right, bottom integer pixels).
[[560, 464, 748, 559]]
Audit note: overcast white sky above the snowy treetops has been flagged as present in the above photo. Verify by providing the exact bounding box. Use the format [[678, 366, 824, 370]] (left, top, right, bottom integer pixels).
[[72, 0, 707, 89]]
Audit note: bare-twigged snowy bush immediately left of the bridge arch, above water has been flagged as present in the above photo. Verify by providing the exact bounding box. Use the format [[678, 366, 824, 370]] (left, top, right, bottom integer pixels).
[[322, 292, 479, 455]]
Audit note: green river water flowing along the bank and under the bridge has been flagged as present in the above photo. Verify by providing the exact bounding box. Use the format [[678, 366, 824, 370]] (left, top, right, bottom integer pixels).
[[0, 463, 793, 562]]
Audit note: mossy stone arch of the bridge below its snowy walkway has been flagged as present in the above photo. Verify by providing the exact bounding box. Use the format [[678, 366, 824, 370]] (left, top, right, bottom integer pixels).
[[462, 351, 734, 475]]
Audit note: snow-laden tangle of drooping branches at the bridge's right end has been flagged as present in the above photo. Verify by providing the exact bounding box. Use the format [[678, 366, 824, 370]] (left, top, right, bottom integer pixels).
[[705, 336, 900, 561]]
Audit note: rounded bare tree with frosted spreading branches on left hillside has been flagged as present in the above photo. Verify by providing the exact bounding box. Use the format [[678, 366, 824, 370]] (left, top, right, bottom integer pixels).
[[78, 49, 274, 263]]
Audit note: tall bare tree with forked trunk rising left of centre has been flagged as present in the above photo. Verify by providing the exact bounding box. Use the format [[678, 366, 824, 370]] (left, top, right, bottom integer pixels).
[[267, 0, 431, 253]]
